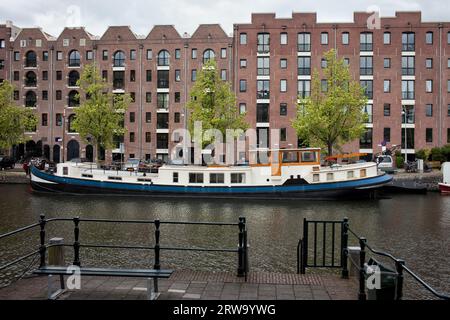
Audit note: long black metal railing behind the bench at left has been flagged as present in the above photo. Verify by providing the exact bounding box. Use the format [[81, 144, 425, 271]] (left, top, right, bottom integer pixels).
[[0, 215, 249, 281]]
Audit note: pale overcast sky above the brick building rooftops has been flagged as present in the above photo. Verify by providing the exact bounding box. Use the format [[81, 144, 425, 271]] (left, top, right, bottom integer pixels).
[[0, 0, 450, 36]]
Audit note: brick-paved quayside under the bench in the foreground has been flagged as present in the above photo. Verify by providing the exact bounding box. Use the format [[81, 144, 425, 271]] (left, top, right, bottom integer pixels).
[[0, 271, 358, 300]]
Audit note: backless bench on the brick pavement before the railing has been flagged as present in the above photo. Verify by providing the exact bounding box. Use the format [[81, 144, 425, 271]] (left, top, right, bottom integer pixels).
[[33, 266, 173, 300]]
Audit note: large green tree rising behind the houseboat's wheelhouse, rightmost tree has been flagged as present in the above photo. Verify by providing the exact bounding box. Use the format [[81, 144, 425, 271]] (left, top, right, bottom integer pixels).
[[292, 50, 367, 155]]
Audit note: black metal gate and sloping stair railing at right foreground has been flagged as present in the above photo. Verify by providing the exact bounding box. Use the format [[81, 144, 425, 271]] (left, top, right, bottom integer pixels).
[[297, 218, 450, 300]]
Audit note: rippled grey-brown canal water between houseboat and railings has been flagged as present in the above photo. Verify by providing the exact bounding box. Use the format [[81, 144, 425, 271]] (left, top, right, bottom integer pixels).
[[0, 185, 450, 298]]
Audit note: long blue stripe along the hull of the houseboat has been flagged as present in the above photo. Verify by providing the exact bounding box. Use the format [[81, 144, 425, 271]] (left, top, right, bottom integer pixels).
[[31, 167, 392, 195]]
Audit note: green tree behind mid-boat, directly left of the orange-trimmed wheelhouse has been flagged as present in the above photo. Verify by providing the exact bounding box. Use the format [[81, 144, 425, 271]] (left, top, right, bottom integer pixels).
[[187, 60, 249, 146]]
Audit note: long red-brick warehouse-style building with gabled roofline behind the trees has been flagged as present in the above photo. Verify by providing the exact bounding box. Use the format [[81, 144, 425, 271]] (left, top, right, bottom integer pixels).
[[0, 12, 450, 161]]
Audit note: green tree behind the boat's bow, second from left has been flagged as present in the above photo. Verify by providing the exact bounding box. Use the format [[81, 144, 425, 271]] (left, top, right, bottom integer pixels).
[[73, 64, 131, 160]]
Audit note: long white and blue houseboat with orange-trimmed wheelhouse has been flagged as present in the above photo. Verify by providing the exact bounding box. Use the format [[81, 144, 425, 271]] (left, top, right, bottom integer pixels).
[[31, 148, 392, 199]]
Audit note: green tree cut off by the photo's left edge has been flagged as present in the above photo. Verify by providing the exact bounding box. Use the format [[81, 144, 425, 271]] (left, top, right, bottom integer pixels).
[[0, 81, 37, 150]]
